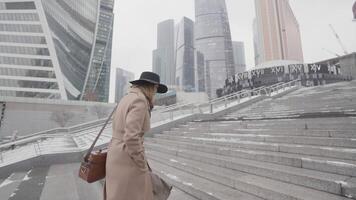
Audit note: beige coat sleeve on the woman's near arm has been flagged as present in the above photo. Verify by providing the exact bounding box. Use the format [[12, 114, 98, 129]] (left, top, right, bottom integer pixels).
[[123, 98, 148, 170]]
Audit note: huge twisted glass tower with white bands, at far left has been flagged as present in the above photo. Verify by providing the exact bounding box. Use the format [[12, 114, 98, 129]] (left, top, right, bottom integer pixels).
[[0, 0, 114, 101]]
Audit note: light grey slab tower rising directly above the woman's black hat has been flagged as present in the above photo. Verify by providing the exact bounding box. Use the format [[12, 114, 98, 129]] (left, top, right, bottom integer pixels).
[[152, 19, 176, 86]]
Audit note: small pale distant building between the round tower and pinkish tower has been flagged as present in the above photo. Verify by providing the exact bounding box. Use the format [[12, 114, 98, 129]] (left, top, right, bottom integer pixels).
[[232, 41, 246, 73]]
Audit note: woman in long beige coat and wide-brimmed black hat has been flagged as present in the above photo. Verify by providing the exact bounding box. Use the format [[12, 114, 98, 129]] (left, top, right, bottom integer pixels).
[[104, 72, 167, 200]]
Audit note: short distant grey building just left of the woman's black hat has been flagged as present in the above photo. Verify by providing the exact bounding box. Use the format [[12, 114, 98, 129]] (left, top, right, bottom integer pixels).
[[115, 68, 135, 102]]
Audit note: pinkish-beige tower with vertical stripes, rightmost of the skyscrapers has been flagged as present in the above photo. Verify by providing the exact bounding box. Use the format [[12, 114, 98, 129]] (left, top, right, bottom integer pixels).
[[254, 0, 303, 65]]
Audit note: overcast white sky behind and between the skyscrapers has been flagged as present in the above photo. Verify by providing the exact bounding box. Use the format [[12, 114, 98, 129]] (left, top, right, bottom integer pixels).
[[110, 0, 356, 102]]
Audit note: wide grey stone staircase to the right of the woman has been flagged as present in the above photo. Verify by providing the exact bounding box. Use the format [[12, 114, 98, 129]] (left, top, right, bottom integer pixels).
[[145, 82, 356, 200]]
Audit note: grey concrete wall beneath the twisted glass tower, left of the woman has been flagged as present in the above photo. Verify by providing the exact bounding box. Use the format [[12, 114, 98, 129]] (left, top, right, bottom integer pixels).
[[0, 99, 115, 139]]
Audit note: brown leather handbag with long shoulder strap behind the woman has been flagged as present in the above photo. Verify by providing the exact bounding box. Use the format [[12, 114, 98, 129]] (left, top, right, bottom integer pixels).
[[79, 105, 117, 183]]
